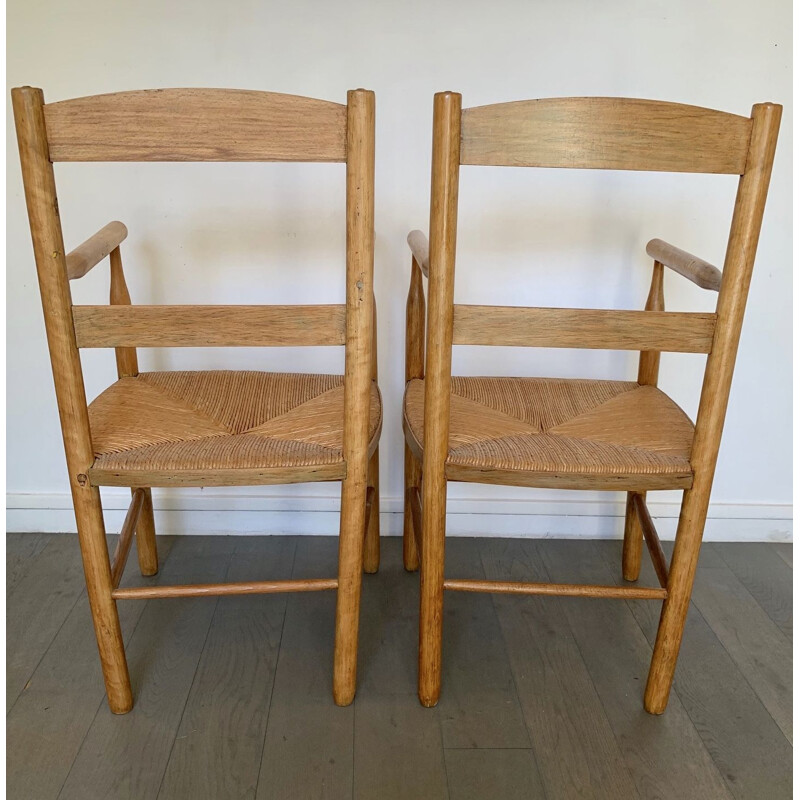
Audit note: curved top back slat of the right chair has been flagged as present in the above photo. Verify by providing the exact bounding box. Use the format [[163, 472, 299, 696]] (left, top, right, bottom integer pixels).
[[461, 97, 751, 174]]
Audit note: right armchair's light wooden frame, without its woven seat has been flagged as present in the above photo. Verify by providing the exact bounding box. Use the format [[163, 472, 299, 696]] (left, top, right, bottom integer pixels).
[[403, 92, 782, 714]]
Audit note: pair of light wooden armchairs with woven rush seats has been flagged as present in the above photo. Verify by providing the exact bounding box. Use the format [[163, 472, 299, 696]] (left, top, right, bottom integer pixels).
[[12, 87, 781, 713]]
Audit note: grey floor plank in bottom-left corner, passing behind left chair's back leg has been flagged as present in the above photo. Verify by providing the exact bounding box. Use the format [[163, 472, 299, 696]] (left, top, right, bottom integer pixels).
[[6, 536, 177, 800]]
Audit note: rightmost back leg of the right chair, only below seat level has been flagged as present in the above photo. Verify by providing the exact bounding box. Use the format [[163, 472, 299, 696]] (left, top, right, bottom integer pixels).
[[644, 489, 709, 714]]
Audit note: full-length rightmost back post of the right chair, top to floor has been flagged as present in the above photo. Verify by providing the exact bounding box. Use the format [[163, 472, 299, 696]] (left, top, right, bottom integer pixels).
[[644, 103, 782, 714]]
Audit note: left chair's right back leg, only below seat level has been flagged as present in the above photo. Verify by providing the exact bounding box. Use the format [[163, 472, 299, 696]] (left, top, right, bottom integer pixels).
[[333, 468, 367, 706]]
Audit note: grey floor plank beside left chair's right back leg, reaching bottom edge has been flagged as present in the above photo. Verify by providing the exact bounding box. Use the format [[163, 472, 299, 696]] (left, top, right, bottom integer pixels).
[[257, 536, 354, 800]]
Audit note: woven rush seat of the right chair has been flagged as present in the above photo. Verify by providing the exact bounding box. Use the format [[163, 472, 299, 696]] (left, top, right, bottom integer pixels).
[[403, 377, 694, 488]]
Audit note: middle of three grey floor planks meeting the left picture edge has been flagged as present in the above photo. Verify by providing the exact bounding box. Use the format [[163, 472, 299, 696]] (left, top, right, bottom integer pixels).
[[6, 533, 85, 712]]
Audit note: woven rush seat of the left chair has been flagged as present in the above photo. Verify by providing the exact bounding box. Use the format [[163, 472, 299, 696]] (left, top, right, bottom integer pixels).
[[89, 371, 381, 486]]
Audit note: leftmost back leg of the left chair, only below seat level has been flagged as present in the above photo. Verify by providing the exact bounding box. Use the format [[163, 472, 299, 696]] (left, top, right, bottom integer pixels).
[[72, 486, 133, 714]]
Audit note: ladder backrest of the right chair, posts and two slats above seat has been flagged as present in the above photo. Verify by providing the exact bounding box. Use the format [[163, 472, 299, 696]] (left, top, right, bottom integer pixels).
[[425, 92, 782, 485]]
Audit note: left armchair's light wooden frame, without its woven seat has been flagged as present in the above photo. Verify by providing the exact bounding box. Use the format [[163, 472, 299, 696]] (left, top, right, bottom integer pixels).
[[11, 86, 380, 714]]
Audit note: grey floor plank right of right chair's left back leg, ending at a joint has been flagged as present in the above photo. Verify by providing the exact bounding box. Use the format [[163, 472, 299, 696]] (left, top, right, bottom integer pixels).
[[438, 537, 531, 748]]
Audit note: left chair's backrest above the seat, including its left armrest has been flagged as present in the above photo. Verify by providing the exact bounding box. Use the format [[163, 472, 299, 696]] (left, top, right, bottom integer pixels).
[[11, 86, 375, 485]]
